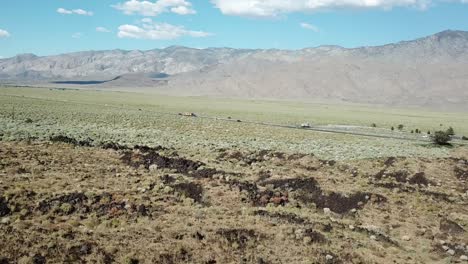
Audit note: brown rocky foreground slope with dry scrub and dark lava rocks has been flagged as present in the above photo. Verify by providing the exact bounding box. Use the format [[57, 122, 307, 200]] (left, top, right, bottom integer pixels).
[[0, 138, 468, 264]]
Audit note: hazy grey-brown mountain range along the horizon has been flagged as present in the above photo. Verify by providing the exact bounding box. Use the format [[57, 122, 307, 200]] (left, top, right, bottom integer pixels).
[[0, 31, 468, 110]]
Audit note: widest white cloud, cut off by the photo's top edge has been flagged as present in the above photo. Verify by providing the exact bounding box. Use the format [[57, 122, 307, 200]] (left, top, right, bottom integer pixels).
[[211, 0, 434, 17]]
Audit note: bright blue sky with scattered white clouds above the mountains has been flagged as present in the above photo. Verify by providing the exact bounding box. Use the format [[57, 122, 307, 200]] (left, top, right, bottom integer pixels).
[[0, 0, 468, 57]]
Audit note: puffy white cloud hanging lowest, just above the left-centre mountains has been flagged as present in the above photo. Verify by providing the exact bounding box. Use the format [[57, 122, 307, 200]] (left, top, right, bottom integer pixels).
[[117, 18, 212, 40]]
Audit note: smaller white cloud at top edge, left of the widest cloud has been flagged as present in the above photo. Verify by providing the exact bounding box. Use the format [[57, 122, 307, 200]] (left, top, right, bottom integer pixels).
[[113, 0, 196, 16]]
